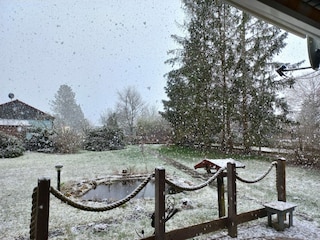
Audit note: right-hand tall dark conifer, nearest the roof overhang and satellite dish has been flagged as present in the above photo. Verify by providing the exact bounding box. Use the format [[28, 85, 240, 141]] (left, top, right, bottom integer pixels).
[[235, 13, 290, 151]]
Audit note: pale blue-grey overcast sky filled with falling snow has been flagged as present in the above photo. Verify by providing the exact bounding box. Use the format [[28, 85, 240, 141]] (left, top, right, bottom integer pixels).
[[0, 0, 309, 124]]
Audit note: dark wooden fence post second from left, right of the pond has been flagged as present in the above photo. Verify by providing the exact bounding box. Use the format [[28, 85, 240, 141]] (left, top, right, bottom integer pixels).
[[154, 168, 166, 240]]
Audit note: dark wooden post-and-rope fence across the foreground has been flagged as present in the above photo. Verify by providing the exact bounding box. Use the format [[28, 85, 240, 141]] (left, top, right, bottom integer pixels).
[[30, 159, 286, 240]]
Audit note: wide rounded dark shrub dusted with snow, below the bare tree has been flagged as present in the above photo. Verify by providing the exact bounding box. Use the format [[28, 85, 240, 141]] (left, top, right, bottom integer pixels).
[[84, 127, 124, 151]]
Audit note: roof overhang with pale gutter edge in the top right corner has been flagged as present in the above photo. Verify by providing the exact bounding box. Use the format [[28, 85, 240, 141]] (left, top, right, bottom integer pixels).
[[224, 0, 320, 41]]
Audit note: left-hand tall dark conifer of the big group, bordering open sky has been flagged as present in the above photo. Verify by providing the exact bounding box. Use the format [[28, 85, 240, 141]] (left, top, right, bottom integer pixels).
[[163, 1, 234, 145]]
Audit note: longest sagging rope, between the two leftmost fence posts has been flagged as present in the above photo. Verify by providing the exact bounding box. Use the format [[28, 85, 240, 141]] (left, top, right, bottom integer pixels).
[[50, 173, 154, 212]]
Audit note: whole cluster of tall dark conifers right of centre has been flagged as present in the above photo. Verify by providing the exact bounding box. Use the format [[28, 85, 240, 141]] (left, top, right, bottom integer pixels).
[[162, 0, 287, 151]]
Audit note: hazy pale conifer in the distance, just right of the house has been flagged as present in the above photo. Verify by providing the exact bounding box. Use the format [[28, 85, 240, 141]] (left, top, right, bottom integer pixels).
[[50, 85, 88, 132]]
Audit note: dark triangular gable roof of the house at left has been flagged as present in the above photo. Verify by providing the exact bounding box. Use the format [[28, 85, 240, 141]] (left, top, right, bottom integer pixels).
[[0, 99, 54, 120]]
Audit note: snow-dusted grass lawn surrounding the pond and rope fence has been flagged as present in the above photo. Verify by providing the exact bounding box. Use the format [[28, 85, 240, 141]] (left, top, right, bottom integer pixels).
[[0, 147, 320, 240]]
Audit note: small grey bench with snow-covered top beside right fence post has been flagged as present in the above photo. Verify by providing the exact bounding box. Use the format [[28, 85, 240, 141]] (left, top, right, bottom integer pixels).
[[264, 201, 297, 231]]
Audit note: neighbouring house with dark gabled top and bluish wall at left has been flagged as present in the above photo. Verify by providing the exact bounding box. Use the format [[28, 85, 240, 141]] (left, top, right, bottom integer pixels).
[[0, 100, 54, 139]]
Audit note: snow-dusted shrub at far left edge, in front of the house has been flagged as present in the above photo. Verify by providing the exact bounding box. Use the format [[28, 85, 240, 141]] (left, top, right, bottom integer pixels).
[[0, 132, 25, 158]]
